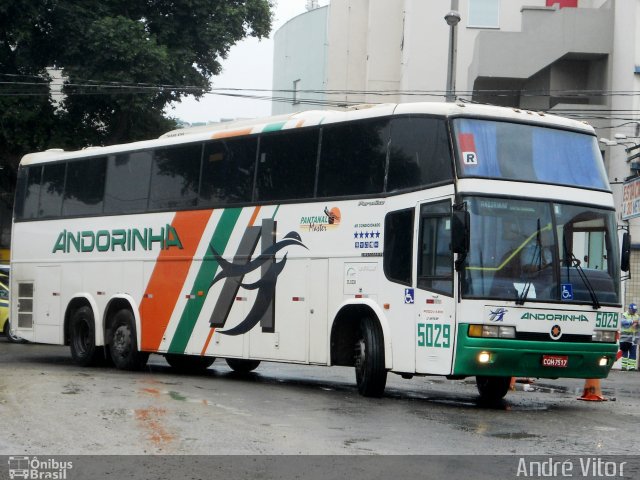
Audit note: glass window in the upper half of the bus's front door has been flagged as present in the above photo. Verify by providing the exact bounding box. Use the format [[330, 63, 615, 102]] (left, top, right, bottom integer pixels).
[[418, 202, 453, 296]]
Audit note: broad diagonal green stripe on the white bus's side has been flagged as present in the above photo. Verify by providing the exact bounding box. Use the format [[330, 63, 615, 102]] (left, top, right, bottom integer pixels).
[[169, 208, 242, 353]]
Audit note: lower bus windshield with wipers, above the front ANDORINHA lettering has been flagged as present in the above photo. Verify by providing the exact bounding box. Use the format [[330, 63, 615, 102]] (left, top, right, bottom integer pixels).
[[463, 197, 620, 306]]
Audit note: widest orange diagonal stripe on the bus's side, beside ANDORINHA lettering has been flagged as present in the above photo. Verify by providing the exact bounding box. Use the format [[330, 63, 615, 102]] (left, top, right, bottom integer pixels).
[[140, 210, 213, 352]]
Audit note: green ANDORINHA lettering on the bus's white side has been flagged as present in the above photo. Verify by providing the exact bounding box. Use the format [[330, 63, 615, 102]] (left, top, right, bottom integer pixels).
[[53, 225, 183, 253]]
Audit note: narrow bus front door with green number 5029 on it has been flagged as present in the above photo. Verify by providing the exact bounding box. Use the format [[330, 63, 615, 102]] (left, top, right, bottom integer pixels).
[[414, 199, 456, 375]]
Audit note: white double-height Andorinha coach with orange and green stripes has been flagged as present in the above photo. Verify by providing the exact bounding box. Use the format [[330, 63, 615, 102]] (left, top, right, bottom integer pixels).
[[11, 103, 628, 399]]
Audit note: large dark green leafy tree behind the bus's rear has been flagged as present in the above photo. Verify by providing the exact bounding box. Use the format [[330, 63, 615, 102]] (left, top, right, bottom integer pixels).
[[0, 0, 272, 180]]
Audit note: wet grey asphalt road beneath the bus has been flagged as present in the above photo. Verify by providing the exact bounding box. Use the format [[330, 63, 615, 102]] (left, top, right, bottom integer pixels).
[[0, 337, 640, 455]]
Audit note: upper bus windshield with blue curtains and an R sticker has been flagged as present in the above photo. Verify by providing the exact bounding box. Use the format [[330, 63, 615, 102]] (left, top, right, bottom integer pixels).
[[453, 118, 609, 190]]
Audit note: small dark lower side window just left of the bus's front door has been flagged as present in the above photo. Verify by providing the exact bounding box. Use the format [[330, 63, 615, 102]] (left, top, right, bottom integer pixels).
[[383, 208, 414, 285]]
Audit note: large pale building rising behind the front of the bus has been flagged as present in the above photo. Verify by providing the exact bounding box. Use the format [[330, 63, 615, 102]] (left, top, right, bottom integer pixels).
[[273, 0, 640, 301]]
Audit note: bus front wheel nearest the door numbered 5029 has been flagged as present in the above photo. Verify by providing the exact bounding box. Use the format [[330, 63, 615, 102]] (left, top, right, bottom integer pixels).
[[355, 317, 387, 397]]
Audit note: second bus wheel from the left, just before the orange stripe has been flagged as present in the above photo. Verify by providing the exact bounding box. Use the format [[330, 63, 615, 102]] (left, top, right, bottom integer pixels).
[[109, 309, 149, 370]]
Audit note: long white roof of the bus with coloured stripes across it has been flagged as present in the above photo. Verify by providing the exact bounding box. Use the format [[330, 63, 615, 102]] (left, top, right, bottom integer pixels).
[[20, 102, 594, 165]]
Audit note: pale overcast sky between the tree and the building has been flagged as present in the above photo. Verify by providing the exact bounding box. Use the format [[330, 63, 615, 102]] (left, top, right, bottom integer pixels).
[[165, 0, 329, 123]]
